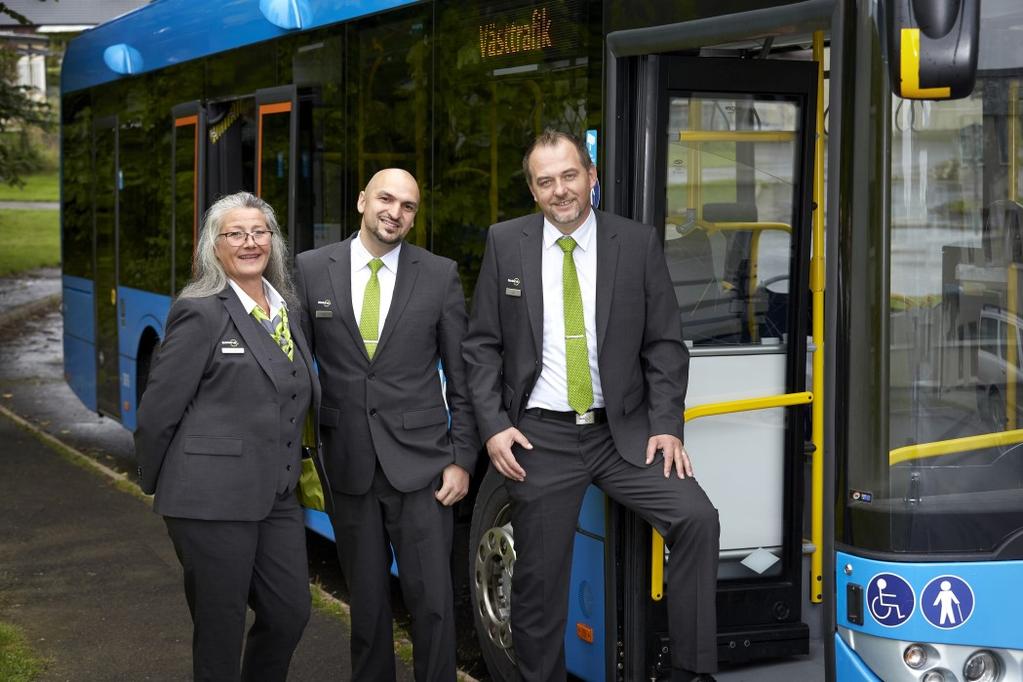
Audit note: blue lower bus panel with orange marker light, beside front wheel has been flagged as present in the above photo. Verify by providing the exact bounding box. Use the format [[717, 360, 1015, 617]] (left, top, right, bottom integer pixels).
[[565, 486, 607, 680]]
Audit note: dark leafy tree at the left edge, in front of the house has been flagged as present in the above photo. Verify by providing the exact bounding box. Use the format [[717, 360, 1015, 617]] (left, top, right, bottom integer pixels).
[[0, 0, 53, 185]]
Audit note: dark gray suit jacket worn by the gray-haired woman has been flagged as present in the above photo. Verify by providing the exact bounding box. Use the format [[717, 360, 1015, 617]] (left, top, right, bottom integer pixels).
[[135, 286, 319, 520]]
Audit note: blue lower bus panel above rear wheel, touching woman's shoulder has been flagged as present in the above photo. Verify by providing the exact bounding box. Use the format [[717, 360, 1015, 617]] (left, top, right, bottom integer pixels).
[[118, 286, 172, 430]]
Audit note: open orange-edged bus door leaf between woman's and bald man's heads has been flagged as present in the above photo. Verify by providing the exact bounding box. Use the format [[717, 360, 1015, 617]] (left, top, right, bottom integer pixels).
[[256, 86, 299, 254]]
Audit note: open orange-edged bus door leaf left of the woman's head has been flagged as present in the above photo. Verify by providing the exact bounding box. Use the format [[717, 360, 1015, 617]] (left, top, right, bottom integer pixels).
[[171, 101, 206, 293]]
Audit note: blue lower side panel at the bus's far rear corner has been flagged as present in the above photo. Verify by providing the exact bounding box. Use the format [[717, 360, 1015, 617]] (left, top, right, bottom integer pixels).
[[62, 275, 96, 410]]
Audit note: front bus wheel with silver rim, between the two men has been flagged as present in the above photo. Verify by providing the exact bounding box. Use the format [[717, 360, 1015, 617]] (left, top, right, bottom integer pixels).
[[469, 468, 515, 680]]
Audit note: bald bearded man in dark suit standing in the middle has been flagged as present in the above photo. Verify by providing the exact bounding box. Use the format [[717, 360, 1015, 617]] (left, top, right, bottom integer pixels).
[[296, 169, 480, 682]]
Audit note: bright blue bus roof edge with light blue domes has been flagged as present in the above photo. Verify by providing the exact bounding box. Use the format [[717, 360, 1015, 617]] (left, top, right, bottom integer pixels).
[[60, 0, 416, 93]]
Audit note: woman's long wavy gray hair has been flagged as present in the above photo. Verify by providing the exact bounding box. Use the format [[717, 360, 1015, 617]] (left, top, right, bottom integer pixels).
[[178, 192, 297, 310]]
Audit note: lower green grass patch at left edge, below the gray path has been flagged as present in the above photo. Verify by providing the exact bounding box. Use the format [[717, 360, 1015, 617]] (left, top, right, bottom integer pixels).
[[0, 210, 60, 278]]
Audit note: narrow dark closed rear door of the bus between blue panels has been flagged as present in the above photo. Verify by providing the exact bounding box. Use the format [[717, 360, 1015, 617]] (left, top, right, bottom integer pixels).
[[92, 117, 121, 419]]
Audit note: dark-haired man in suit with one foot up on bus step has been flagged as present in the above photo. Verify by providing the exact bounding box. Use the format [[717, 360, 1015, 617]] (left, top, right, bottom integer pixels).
[[462, 130, 719, 682]]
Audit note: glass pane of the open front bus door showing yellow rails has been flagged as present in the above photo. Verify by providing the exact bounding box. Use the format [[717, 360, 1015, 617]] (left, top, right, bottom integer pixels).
[[664, 93, 799, 346]]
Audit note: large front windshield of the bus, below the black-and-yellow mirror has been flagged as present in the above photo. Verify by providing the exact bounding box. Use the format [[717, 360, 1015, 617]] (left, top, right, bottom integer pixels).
[[848, 0, 1023, 553]]
